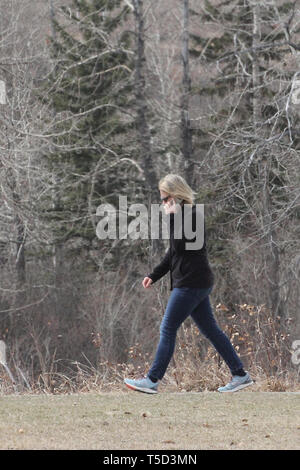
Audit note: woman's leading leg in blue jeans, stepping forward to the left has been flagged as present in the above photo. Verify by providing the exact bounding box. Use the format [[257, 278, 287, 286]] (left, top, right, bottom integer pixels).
[[148, 287, 210, 380]]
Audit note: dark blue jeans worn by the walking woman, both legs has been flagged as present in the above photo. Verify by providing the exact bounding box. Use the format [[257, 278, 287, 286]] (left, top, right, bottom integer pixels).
[[148, 287, 243, 380]]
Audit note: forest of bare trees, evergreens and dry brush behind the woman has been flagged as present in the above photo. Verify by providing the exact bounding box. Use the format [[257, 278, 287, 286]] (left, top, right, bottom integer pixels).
[[0, 0, 300, 393]]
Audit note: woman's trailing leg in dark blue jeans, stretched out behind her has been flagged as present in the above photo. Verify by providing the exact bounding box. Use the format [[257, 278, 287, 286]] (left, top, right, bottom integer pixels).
[[191, 296, 243, 375]]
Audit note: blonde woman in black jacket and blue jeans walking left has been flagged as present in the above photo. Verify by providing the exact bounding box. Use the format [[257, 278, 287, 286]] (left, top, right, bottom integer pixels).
[[124, 174, 253, 393]]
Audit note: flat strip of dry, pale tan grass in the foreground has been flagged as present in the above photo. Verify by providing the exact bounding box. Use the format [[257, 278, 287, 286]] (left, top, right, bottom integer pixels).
[[0, 390, 300, 450]]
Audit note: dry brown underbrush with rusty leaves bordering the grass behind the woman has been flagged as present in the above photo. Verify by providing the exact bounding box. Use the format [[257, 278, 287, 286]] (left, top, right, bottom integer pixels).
[[0, 304, 299, 394]]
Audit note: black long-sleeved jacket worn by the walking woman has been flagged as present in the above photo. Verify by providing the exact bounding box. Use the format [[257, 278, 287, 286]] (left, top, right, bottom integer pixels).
[[147, 204, 214, 290]]
